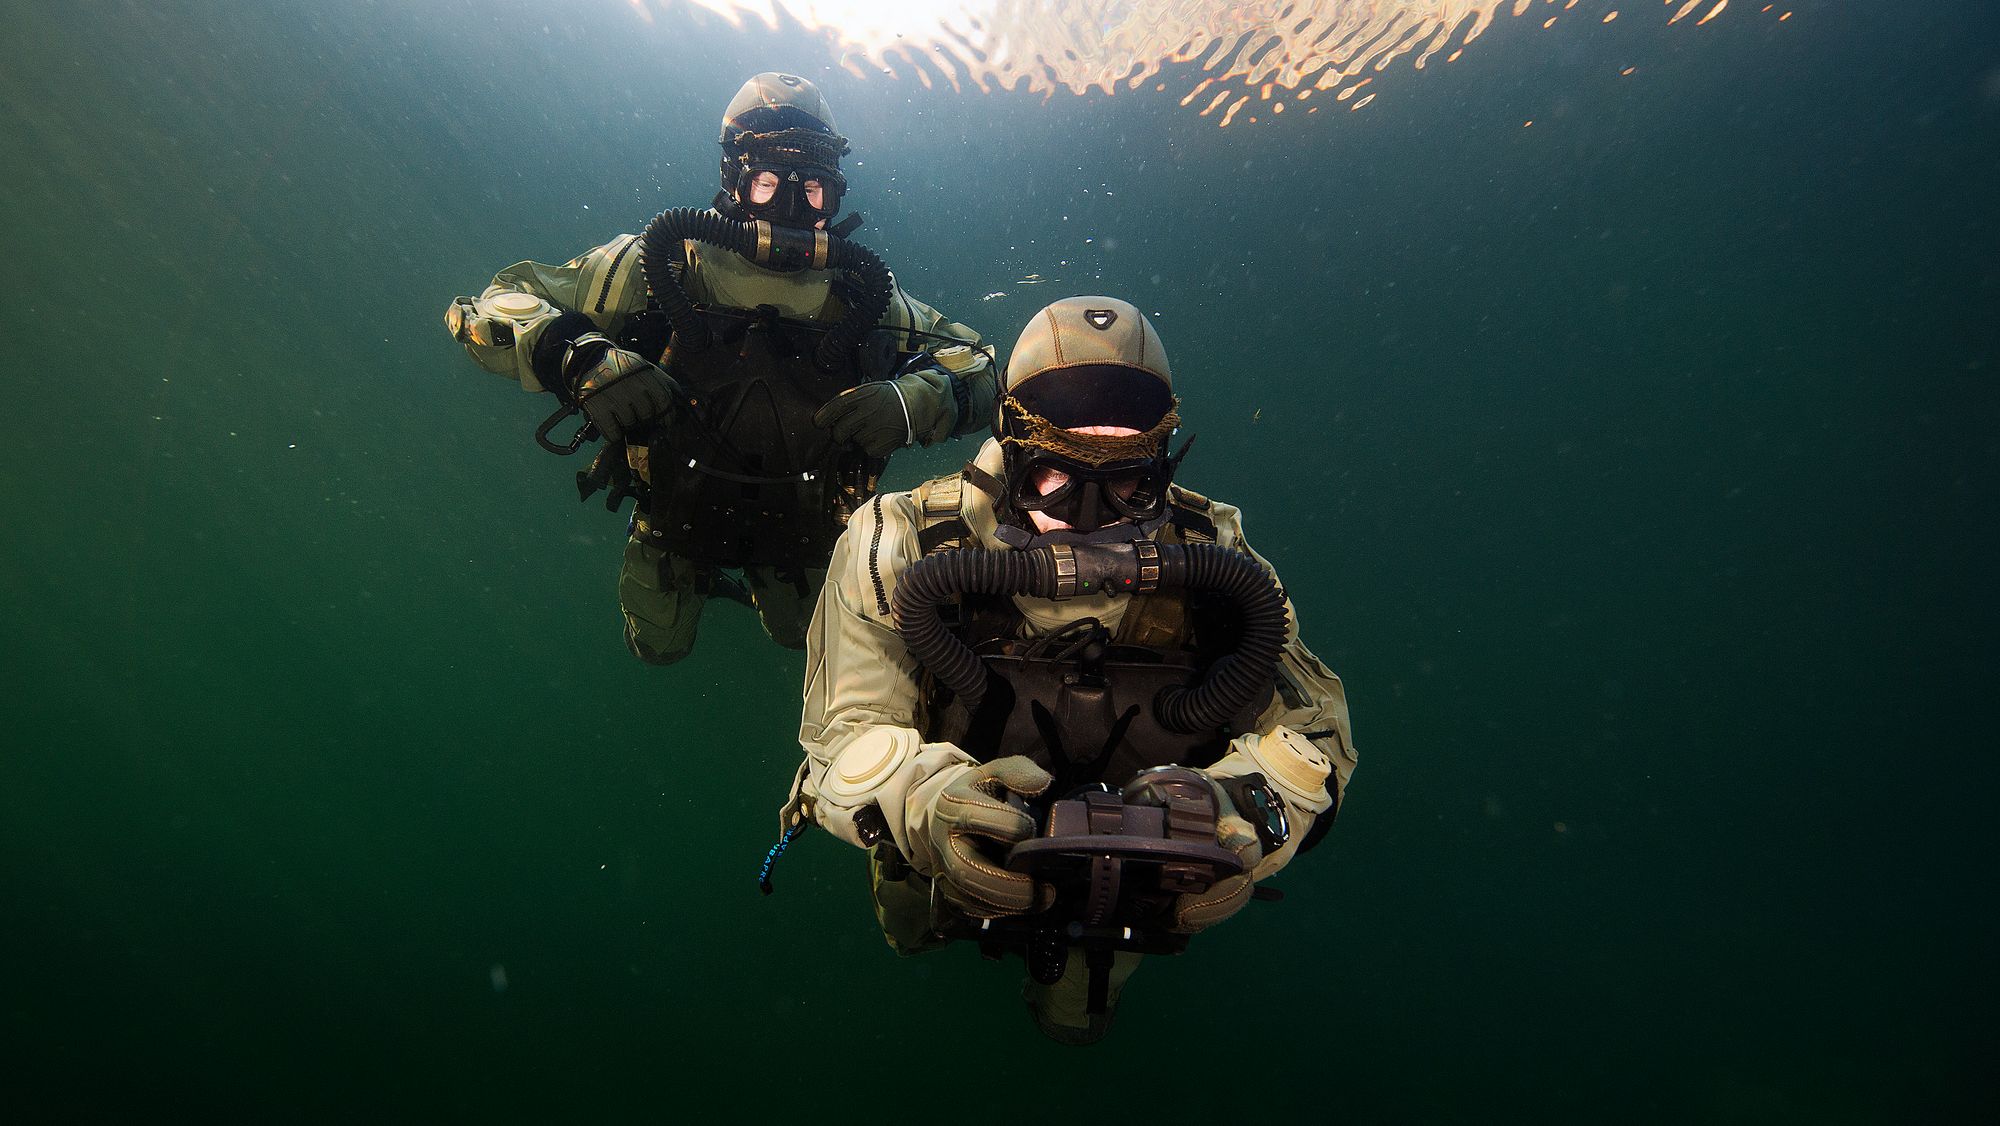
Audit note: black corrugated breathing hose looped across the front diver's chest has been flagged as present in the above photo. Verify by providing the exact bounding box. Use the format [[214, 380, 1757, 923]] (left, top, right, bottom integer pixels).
[[890, 544, 1288, 734]]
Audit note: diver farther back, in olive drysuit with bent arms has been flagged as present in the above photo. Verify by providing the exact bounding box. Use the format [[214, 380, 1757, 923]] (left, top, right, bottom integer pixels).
[[446, 74, 994, 664]]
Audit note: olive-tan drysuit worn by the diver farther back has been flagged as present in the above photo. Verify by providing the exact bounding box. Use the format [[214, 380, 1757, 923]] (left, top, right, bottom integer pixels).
[[466, 234, 994, 664]]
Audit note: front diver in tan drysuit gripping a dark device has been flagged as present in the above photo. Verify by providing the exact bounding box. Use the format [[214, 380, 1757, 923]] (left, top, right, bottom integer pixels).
[[782, 296, 1356, 1042]]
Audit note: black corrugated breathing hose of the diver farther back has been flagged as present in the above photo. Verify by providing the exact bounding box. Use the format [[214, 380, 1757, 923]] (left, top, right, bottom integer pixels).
[[638, 208, 896, 372]]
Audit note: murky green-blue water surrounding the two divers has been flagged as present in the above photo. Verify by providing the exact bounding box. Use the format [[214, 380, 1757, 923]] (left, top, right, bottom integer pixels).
[[0, 0, 2000, 1124]]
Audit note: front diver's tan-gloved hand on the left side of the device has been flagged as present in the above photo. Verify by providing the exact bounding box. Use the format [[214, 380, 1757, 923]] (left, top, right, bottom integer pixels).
[[928, 754, 1056, 918]]
